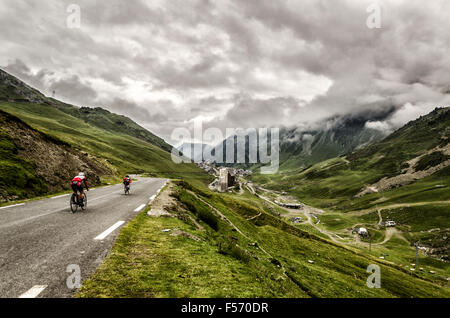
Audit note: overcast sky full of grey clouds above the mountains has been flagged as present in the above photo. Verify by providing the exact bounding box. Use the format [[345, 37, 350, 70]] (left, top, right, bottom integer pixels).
[[0, 0, 450, 142]]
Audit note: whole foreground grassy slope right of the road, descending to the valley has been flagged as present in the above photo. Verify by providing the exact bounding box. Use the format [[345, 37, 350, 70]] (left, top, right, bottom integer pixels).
[[77, 182, 450, 297]]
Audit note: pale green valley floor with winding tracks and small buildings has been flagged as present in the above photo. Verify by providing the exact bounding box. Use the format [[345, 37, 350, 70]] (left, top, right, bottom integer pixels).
[[243, 181, 450, 278]]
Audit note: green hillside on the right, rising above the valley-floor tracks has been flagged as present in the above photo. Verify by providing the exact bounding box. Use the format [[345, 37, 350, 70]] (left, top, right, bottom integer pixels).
[[252, 108, 450, 211]]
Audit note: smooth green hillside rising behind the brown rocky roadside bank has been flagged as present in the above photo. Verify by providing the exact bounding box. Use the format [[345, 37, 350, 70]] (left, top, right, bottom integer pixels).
[[0, 102, 205, 183]]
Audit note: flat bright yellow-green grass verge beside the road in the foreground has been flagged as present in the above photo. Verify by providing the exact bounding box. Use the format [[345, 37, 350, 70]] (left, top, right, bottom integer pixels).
[[78, 200, 306, 297]]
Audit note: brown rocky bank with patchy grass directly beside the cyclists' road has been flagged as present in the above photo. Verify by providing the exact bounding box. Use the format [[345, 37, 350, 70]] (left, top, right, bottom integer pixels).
[[0, 110, 113, 202]]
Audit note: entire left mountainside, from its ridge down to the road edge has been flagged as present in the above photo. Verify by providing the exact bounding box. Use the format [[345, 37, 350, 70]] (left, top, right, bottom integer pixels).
[[0, 71, 210, 204]]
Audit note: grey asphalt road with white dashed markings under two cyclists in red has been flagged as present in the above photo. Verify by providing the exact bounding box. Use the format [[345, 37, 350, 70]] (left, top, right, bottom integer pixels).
[[0, 178, 166, 298]]
